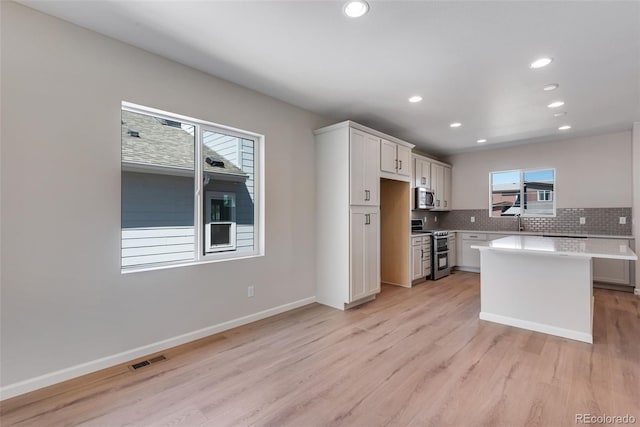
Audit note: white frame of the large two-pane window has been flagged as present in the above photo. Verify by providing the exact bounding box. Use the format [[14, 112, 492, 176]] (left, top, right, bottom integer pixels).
[[120, 101, 265, 274]]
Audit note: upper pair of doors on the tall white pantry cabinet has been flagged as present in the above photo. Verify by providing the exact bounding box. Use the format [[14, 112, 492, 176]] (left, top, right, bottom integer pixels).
[[349, 128, 380, 206]]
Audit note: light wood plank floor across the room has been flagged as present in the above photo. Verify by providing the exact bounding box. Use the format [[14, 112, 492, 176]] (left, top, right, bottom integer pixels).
[[0, 272, 640, 427]]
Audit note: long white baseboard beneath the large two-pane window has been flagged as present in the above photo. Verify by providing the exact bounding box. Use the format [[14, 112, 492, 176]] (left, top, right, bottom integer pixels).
[[0, 297, 316, 400]]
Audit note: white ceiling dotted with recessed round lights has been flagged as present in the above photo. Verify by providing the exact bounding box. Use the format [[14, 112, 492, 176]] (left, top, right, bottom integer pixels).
[[20, 0, 640, 155]]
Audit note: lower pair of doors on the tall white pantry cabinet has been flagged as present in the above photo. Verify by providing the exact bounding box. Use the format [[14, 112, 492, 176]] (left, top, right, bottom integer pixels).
[[348, 206, 380, 303]]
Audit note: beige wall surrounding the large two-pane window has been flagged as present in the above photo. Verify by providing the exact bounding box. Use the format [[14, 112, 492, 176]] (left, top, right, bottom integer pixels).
[[0, 1, 329, 387]]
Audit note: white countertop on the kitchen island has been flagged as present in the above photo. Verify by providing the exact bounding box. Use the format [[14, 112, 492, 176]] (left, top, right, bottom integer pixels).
[[471, 235, 638, 260]]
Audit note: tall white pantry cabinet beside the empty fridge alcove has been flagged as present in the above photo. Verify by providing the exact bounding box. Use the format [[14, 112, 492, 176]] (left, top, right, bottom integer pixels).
[[314, 122, 380, 310]]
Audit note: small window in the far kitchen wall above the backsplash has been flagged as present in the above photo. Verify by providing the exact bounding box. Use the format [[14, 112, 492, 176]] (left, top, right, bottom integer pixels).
[[489, 169, 556, 217]]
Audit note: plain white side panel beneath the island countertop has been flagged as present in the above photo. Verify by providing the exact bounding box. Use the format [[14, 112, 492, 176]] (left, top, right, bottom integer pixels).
[[480, 249, 593, 343]]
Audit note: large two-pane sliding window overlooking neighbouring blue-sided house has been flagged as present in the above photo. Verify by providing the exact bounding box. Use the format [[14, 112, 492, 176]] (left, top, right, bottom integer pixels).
[[121, 103, 264, 271]]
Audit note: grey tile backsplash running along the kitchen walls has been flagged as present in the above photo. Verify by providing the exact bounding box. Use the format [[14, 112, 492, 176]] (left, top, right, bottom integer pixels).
[[412, 208, 631, 236]]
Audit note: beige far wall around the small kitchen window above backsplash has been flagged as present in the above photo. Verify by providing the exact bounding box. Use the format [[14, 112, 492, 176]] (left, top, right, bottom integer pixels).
[[446, 131, 632, 209]]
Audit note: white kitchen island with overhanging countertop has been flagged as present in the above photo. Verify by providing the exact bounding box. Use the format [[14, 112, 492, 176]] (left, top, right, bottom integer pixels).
[[471, 236, 637, 343]]
